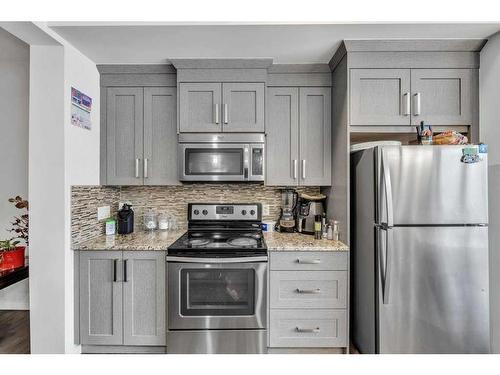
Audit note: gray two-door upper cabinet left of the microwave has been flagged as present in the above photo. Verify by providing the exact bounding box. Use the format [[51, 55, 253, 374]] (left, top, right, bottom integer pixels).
[[105, 87, 179, 185]]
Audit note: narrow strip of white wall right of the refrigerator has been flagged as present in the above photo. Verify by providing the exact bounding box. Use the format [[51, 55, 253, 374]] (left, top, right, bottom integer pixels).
[[479, 33, 500, 353]]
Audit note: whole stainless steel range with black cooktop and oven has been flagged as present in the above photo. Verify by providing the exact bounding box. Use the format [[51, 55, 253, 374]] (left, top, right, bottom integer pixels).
[[167, 203, 267, 353]]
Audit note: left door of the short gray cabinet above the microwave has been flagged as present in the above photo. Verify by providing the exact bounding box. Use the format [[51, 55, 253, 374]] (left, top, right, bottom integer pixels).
[[179, 82, 222, 133]]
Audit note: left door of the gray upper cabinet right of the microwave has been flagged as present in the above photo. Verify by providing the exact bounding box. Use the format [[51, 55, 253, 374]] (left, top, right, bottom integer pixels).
[[266, 87, 299, 186]]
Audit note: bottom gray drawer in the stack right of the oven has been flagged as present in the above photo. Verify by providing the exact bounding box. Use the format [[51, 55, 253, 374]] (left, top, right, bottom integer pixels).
[[269, 310, 347, 348]]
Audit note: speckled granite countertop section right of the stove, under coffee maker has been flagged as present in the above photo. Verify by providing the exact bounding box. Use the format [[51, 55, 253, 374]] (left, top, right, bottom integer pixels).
[[264, 232, 349, 251]]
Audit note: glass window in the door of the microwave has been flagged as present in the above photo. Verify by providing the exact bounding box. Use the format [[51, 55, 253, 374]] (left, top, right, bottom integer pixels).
[[184, 148, 244, 175]]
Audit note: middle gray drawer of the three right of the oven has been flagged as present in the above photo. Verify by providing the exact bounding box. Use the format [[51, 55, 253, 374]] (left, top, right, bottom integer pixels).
[[270, 271, 347, 309]]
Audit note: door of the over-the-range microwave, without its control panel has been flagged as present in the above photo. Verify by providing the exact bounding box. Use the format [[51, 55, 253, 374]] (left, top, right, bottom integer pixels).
[[179, 143, 250, 181]]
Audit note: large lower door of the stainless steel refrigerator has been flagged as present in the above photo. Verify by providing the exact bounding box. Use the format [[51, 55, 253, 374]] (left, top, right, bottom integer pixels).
[[377, 227, 490, 353]]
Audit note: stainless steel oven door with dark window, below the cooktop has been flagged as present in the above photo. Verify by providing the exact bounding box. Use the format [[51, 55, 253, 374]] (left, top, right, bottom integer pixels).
[[168, 257, 267, 330]]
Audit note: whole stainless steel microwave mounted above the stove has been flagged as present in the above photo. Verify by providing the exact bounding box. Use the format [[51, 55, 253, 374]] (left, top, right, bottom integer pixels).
[[179, 133, 265, 181]]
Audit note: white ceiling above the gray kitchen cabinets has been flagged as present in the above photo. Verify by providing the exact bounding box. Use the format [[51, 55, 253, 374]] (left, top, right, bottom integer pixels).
[[48, 22, 500, 64]]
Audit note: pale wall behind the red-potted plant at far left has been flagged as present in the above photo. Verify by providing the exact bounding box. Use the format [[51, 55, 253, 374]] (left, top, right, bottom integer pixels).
[[0, 28, 29, 310]]
